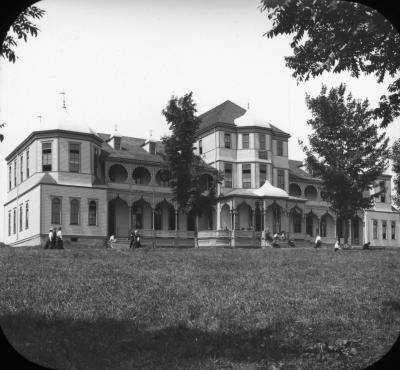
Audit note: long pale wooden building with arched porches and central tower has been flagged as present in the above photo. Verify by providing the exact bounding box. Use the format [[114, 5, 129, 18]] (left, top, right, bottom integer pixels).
[[4, 101, 400, 247]]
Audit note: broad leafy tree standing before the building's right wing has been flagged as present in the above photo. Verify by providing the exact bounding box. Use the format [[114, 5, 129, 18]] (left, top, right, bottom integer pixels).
[[300, 84, 389, 242]]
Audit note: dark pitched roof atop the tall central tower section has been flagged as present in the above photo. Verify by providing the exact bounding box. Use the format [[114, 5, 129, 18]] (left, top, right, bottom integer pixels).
[[199, 100, 246, 130]]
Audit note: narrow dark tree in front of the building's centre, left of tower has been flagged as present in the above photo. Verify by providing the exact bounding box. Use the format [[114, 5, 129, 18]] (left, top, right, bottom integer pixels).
[[162, 92, 220, 243]]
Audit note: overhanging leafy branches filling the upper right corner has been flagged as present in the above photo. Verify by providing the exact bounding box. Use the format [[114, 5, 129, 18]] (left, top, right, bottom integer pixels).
[[260, 0, 400, 127]]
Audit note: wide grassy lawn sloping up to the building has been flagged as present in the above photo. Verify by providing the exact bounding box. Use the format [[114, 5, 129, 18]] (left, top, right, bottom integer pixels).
[[0, 248, 400, 369]]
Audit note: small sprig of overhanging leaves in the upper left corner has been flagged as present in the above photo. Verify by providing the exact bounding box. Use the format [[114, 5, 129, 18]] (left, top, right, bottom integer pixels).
[[0, 6, 45, 63]]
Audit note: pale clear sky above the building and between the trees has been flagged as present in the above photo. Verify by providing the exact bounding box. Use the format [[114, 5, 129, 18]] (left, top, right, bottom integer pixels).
[[0, 0, 400, 241]]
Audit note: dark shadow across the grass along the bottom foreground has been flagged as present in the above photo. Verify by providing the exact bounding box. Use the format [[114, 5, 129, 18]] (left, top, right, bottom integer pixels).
[[0, 311, 301, 369]]
